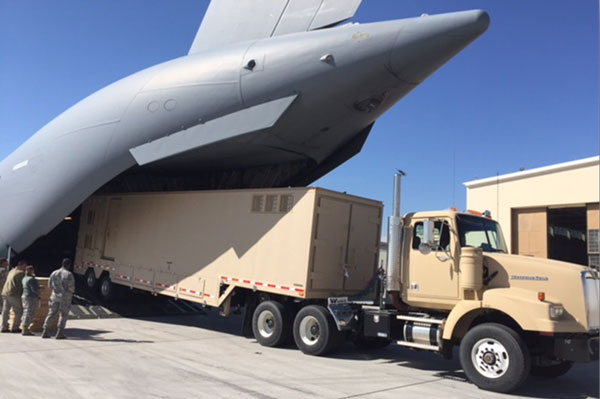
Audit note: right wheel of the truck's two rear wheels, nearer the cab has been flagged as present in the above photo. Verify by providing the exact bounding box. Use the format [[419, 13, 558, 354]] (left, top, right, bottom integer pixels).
[[294, 305, 341, 356]]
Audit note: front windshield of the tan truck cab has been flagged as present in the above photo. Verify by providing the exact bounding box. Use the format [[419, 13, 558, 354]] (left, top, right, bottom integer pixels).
[[456, 215, 508, 253]]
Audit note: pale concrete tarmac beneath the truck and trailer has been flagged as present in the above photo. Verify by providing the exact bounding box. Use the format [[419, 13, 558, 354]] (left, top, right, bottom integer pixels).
[[0, 310, 599, 399]]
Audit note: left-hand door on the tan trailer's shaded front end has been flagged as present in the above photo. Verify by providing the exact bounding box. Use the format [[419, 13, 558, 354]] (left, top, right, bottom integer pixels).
[[310, 197, 350, 291]]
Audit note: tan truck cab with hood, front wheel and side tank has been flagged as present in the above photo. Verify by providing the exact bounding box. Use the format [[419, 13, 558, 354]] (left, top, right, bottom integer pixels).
[[364, 210, 600, 392]]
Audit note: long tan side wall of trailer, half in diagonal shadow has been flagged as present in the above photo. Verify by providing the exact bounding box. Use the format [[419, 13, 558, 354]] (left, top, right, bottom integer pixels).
[[78, 188, 314, 306]]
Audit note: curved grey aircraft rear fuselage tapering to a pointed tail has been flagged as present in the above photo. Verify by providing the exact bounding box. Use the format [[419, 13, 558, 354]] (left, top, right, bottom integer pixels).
[[0, 11, 489, 254]]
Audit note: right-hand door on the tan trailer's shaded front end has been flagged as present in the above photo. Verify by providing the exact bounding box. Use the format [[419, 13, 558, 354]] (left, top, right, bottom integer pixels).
[[344, 204, 381, 292]]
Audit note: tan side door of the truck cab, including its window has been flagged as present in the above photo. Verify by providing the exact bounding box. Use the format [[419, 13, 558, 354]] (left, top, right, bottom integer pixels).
[[406, 220, 459, 301]]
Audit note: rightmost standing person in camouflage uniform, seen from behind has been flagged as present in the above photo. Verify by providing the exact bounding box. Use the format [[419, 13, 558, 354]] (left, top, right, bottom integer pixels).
[[42, 258, 75, 339]]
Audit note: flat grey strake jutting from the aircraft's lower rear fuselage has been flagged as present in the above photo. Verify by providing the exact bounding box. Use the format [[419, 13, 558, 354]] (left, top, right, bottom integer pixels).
[[129, 94, 298, 166]]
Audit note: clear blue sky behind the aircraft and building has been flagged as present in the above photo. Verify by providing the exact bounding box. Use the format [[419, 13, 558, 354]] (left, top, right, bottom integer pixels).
[[0, 0, 599, 222]]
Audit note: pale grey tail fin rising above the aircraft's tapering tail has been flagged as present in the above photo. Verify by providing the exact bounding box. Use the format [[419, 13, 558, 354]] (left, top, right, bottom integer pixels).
[[189, 0, 362, 54]]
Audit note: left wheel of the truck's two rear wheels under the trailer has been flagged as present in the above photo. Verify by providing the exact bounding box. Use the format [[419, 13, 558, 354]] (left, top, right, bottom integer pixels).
[[252, 301, 292, 347]]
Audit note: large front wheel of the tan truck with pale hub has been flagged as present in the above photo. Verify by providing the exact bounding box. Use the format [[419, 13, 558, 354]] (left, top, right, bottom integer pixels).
[[460, 323, 531, 392]]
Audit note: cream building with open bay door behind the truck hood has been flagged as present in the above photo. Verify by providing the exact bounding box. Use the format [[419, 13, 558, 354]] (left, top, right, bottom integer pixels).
[[464, 157, 600, 268]]
